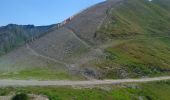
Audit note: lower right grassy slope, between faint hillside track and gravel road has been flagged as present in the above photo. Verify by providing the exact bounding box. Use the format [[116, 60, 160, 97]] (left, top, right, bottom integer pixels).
[[97, 38, 170, 78]]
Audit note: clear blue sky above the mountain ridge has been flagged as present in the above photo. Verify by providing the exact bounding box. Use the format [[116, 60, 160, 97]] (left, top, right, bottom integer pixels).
[[0, 0, 104, 26]]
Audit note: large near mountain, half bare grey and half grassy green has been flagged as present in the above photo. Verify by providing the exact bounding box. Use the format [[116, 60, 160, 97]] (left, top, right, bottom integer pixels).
[[0, 0, 170, 79]]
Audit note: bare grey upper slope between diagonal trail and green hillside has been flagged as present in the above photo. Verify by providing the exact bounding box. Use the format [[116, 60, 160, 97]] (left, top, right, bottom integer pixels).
[[65, 0, 122, 44]]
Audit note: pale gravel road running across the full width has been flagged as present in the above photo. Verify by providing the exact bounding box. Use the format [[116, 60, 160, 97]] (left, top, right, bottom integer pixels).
[[0, 76, 170, 87]]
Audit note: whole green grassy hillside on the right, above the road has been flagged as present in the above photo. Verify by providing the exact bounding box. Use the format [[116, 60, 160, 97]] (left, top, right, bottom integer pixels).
[[96, 0, 170, 78]]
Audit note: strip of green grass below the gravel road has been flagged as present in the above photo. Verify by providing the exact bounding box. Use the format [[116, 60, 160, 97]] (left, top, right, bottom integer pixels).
[[0, 81, 170, 100]]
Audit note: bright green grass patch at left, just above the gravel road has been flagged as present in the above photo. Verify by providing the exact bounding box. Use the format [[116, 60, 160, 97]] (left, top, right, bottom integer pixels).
[[0, 68, 83, 80]]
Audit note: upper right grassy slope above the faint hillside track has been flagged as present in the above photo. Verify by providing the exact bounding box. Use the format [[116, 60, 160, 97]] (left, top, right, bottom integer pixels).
[[99, 0, 170, 38]]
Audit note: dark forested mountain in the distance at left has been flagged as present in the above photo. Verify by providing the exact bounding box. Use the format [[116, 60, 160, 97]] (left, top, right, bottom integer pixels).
[[0, 24, 54, 55]]
